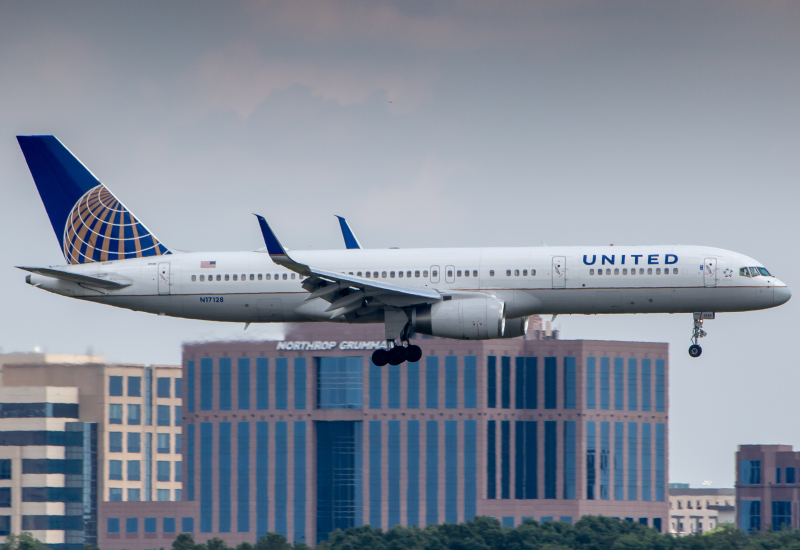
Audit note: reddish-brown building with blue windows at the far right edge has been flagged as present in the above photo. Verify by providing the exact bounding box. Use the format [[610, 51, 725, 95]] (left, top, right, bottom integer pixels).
[[736, 445, 800, 531]]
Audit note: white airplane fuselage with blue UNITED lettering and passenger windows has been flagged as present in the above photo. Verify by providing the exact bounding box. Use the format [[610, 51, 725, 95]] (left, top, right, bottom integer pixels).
[[28, 246, 790, 323]]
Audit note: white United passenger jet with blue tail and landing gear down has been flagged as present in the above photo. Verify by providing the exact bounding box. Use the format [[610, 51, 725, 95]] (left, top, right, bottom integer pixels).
[[17, 136, 791, 366]]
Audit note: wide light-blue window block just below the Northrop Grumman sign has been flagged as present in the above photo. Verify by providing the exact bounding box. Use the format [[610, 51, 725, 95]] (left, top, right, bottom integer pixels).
[[316, 357, 364, 409]]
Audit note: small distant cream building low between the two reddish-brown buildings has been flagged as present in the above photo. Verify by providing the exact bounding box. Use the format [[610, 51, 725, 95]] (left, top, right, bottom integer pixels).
[[669, 490, 736, 535]]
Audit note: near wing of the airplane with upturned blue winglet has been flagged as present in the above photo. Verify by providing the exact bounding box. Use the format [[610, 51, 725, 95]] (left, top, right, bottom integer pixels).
[[255, 214, 442, 318]]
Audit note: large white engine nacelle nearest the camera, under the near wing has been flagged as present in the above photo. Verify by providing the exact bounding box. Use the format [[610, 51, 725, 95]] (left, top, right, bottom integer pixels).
[[414, 298, 506, 340]]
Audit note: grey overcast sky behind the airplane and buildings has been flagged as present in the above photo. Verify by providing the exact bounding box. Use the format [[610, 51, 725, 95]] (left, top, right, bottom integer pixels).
[[0, 0, 800, 487]]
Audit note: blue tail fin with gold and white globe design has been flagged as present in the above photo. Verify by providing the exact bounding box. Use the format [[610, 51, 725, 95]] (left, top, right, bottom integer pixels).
[[17, 136, 170, 264]]
